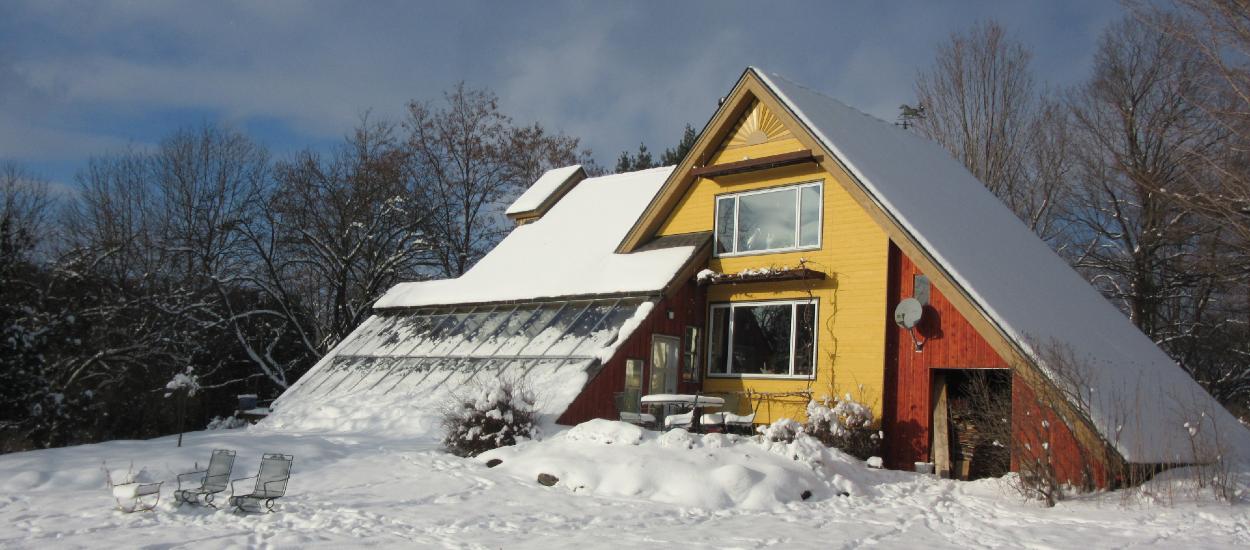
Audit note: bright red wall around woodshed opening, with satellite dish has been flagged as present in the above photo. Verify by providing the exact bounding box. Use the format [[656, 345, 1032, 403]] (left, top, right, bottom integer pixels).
[[883, 244, 1106, 486]]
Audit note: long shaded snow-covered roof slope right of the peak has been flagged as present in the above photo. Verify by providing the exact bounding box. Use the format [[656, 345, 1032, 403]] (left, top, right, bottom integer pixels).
[[751, 69, 1250, 463]]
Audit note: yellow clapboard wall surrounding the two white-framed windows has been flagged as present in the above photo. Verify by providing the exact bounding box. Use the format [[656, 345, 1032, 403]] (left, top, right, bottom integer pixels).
[[659, 150, 889, 423]]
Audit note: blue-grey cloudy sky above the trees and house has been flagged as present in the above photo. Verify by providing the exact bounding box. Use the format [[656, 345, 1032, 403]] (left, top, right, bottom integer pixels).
[[0, 0, 1124, 189]]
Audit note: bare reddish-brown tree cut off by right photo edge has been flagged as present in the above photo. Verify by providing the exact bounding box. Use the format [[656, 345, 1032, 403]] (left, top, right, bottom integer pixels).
[[1105, 0, 1250, 413]]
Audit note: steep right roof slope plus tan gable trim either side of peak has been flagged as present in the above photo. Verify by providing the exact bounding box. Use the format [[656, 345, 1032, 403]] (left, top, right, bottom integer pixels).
[[620, 69, 1250, 464]]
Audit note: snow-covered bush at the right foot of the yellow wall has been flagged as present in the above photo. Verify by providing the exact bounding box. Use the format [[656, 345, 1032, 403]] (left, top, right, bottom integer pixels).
[[803, 394, 881, 460]]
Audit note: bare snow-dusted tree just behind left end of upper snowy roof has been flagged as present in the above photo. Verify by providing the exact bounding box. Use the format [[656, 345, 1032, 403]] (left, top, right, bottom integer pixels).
[[261, 119, 433, 356]]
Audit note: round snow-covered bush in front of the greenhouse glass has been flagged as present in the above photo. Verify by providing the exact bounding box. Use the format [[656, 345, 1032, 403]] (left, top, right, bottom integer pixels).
[[443, 379, 538, 456]]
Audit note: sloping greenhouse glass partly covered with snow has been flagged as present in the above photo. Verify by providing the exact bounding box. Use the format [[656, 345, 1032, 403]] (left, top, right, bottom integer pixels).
[[270, 298, 653, 433]]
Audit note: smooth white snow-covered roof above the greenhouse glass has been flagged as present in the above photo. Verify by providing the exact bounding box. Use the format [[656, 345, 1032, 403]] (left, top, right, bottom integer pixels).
[[374, 166, 696, 308]]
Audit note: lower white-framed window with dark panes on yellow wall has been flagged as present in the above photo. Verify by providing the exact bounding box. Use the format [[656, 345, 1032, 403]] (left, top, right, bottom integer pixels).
[[708, 300, 819, 379]]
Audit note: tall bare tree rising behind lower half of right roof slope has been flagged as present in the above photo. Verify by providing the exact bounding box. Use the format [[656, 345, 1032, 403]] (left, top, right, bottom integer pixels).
[[1069, 13, 1245, 412]]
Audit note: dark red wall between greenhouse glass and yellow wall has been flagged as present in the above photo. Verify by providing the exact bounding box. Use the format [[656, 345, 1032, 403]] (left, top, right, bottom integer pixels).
[[556, 280, 706, 425]]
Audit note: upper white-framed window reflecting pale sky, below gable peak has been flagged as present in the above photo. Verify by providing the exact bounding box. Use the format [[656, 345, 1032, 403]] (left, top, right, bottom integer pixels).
[[715, 181, 824, 256]]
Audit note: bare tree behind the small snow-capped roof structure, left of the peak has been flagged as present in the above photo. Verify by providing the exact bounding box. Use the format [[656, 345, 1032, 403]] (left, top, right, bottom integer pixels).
[[405, 83, 589, 278]]
